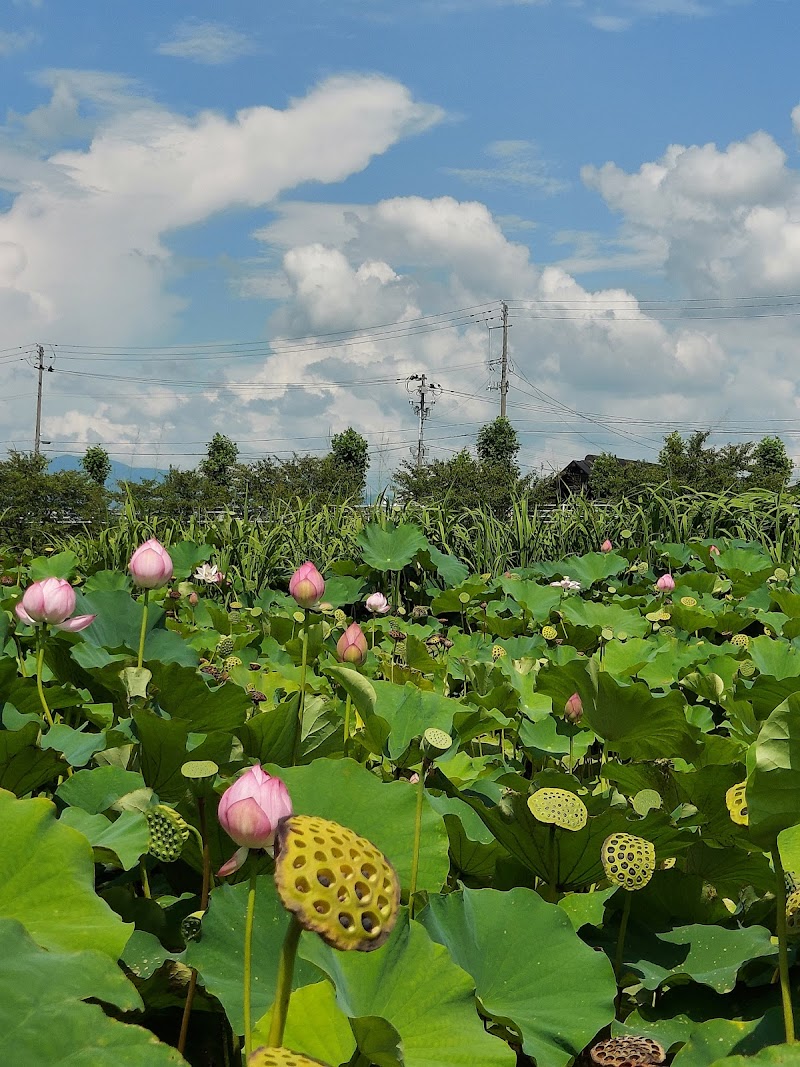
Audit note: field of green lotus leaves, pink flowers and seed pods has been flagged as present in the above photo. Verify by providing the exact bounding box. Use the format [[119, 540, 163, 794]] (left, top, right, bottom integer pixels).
[[0, 519, 800, 1067]]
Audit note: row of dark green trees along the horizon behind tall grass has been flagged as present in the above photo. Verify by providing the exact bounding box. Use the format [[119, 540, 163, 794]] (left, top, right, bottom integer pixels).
[[0, 418, 791, 546]]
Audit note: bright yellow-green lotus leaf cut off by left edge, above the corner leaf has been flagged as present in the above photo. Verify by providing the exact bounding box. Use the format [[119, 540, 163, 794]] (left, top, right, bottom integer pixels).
[[0, 790, 131, 956]]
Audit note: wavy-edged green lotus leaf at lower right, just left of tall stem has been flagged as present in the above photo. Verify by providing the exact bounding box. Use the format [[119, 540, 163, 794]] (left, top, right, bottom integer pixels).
[[625, 924, 778, 993]]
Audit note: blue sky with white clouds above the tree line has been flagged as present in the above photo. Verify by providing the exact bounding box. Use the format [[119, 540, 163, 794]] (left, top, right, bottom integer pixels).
[[0, 0, 800, 482]]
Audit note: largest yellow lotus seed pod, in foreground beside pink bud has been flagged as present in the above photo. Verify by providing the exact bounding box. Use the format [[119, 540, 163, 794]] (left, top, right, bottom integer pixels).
[[275, 815, 400, 952]]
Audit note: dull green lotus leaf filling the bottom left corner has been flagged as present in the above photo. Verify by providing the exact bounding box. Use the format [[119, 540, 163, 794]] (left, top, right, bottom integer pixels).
[[0, 920, 186, 1067]]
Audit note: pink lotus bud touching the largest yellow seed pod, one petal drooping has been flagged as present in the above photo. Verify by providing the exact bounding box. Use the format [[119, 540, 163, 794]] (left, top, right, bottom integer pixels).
[[217, 764, 292, 878]]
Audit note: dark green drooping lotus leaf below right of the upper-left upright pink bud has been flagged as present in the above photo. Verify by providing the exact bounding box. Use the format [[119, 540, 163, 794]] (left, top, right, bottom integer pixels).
[[148, 663, 252, 733]]
